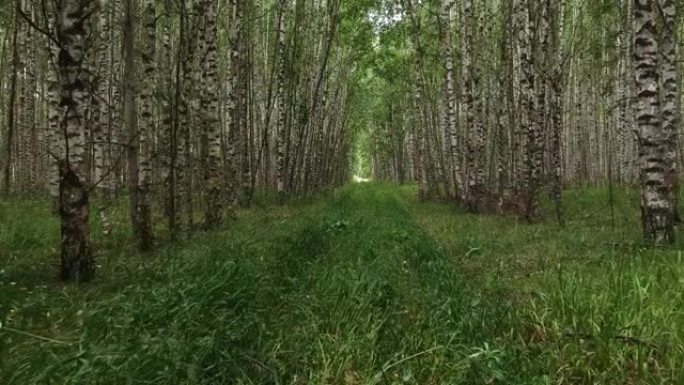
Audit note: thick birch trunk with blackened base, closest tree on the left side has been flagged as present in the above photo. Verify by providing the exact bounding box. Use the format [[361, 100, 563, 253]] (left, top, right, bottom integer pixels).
[[54, 0, 95, 282]]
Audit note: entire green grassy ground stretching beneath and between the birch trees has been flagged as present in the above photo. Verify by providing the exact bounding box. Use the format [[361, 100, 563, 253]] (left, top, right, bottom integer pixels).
[[0, 183, 684, 385]]
